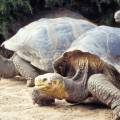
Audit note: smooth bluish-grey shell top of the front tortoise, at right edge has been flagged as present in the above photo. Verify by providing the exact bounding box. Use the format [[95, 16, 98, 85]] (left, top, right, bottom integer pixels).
[[66, 26, 120, 71]]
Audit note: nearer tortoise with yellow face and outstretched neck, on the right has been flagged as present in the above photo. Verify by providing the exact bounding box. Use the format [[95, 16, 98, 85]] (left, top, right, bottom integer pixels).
[[32, 26, 120, 120]]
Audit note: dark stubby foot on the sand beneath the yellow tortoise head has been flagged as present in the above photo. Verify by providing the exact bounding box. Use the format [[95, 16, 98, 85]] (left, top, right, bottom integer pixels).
[[32, 90, 55, 106]]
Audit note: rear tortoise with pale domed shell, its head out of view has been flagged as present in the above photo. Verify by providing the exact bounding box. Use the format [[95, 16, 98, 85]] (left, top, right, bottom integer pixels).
[[1, 17, 96, 104]]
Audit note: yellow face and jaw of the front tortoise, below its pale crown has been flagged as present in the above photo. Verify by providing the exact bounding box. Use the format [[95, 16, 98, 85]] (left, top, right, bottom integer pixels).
[[35, 79, 68, 99]]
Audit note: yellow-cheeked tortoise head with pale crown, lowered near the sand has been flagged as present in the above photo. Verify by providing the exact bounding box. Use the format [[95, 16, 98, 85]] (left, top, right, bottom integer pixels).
[[33, 73, 68, 101]]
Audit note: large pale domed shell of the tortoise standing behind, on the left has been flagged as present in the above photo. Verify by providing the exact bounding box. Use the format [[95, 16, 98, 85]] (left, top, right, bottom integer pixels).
[[3, 17, 96, 71]]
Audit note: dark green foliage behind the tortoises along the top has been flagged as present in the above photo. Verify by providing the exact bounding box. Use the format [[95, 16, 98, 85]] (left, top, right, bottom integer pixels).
[[0, 0, 120, 41]]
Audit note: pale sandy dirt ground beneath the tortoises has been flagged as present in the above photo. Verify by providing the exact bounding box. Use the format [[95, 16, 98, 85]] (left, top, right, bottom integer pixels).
[[0, 79, 112, 120]]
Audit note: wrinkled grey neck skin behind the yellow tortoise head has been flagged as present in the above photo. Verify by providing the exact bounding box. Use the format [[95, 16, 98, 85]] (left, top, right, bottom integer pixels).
[[63, 61, 90, 103]]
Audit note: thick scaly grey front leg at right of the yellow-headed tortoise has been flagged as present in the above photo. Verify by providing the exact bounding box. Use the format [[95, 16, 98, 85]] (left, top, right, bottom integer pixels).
[[87, 74, 120, 120]]
